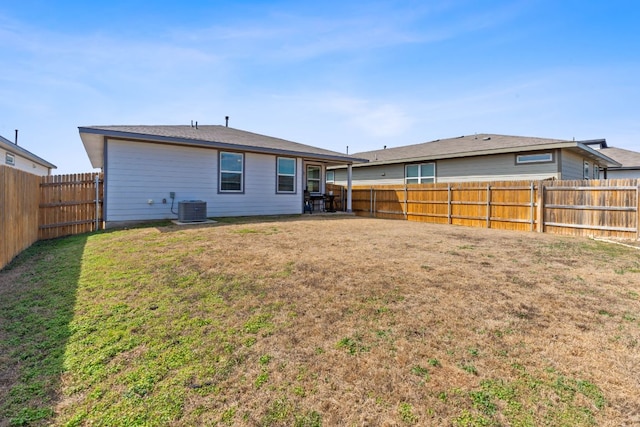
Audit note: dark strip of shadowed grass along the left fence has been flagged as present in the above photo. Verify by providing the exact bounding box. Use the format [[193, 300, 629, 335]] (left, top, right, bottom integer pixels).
[[0, 234, 88, 427]]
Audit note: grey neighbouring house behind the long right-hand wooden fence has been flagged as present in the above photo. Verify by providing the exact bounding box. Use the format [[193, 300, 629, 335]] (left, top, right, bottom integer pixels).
[[327, 134, 620, 185]]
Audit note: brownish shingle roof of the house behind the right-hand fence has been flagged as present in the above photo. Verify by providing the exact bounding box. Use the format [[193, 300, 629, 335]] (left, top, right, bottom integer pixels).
[[336, 134, 619, 167]]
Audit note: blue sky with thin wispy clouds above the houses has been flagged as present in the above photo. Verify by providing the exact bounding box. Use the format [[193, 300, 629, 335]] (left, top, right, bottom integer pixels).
[[0, 0, 640, 173]]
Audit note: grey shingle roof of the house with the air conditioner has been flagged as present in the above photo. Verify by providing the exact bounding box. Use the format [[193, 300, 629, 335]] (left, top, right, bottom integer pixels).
[[78, 125, 363, 168]]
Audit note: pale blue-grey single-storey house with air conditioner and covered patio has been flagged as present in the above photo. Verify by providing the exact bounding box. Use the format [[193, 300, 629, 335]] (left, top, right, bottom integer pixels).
[[79, 124, 358, 227]]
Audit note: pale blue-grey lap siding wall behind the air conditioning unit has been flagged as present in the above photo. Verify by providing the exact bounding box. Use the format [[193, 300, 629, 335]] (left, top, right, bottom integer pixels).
[[105, 140, 302, 222]]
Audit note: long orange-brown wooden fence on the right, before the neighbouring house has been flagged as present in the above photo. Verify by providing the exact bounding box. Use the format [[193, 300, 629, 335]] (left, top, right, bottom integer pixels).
[[350, 179, 640, 239]]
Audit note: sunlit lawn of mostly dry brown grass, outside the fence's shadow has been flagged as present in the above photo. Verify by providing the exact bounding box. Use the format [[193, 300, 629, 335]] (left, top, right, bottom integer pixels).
[[0, 216, 640, 426]]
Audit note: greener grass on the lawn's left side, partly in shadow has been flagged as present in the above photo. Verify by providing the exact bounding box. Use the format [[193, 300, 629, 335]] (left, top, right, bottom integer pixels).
[[0, 228, 328, 426]]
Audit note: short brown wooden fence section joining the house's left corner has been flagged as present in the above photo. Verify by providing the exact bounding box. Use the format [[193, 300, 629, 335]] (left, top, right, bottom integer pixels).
[[38, 173, 103, 240]]
